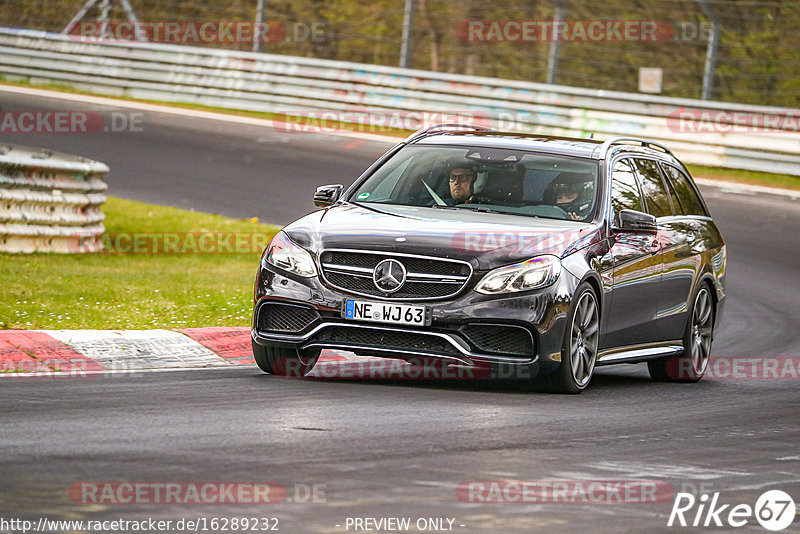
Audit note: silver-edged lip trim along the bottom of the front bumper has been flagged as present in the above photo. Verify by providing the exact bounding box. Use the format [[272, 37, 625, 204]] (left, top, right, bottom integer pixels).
[[252, 322, 538, 366]]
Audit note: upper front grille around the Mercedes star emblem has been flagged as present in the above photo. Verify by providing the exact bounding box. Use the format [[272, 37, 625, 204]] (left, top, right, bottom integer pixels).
[[320, 251, 472, 300]]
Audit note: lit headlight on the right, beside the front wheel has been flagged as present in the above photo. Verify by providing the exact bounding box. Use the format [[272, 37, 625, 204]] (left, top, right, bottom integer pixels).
[[475, 256, 561, 295]]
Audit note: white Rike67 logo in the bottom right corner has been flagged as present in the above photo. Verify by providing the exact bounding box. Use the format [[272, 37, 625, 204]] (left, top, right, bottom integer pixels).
[[667, 490, 796, 532]]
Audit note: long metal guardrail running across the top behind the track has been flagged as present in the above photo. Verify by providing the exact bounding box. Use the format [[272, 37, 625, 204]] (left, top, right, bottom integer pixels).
[[0, 28, 800, 175]]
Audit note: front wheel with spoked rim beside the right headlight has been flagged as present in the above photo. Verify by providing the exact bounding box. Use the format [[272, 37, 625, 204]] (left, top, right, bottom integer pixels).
[[538, 282, 600, 395]]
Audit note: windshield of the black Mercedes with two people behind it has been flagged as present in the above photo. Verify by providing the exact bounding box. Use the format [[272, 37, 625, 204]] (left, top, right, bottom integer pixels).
[[350, 145, 598, 221]]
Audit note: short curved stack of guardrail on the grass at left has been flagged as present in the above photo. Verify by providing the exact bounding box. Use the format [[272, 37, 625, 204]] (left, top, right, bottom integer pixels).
[[0, 145, 109, 253]]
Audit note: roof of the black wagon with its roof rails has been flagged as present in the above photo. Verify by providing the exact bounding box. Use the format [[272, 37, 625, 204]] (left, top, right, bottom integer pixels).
[[409, 130, 682, 166]]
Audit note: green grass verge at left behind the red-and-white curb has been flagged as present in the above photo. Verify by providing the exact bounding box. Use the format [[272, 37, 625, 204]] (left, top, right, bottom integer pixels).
[[0, 197, 278, 329]]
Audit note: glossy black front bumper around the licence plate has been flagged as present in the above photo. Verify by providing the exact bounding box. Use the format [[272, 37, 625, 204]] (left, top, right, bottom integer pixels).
[[252, 265, 577, 373]]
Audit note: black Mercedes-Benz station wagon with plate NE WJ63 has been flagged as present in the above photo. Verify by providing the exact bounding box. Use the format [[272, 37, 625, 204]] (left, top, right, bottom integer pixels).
[[252, 125, 726, 393]]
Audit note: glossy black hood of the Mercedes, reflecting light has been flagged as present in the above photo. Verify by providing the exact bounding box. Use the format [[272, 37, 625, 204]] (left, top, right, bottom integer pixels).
[[284, 203, 599, 270]]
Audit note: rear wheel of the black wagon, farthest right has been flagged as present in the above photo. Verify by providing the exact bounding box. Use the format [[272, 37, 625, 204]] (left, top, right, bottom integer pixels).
[[647, 282, 716, 383]]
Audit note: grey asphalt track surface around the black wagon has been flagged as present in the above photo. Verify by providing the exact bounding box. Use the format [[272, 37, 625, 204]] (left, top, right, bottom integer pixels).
[[0, 92, 800, 533]]
